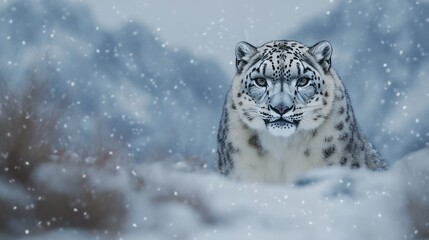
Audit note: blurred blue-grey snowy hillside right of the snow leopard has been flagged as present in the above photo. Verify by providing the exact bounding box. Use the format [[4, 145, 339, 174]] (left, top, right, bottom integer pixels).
[[285, 0, 429, 161]]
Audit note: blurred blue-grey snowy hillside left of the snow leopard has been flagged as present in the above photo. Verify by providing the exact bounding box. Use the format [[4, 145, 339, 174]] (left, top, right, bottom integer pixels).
[[0, 0, 228, 161]]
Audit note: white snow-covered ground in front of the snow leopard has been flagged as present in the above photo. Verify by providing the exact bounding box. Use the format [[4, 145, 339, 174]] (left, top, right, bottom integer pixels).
[[9, 148, 429, 239]]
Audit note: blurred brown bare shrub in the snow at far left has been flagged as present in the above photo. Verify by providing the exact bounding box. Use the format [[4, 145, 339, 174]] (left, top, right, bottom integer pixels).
[[0, 76, 133, 236]]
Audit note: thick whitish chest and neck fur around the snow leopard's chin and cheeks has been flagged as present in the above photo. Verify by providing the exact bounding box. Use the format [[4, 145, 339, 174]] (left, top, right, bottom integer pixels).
[[226, 69, 344, 184]]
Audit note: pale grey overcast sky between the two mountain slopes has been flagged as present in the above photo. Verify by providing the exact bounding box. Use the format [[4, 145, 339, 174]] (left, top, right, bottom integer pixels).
[[69, 0, 338, 75]]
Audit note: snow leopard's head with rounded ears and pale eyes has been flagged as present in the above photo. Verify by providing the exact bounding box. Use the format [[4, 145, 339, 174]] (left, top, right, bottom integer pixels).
[[231, 41, 333, 137]]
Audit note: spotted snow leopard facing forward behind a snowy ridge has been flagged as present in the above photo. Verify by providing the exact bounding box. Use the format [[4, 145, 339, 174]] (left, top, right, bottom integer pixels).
[[217, 40, 387, 184]]
